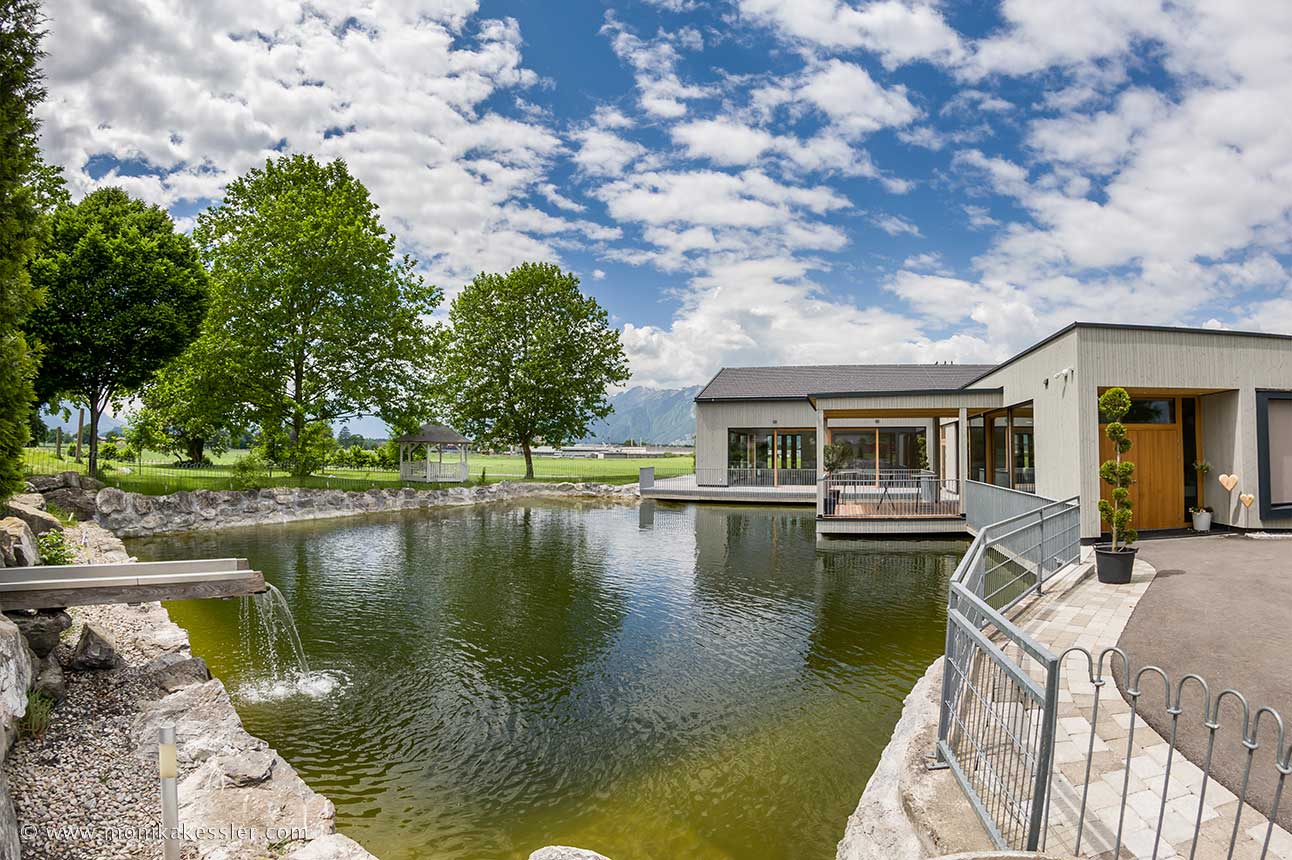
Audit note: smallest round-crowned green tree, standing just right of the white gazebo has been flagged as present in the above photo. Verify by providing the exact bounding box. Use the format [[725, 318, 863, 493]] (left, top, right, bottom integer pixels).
[[441, 263, 629, 478]]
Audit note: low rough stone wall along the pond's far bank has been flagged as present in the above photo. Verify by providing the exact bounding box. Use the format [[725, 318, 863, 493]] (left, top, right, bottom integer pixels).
[[94, 482, 638, 537]]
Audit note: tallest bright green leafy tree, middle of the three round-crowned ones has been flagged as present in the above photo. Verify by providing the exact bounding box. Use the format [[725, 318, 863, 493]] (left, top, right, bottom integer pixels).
[[194, 155, 441, 476]]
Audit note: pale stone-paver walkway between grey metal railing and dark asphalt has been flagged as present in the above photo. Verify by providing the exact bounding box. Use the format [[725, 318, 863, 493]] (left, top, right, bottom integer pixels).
[[1002, 550, 1292, 860]]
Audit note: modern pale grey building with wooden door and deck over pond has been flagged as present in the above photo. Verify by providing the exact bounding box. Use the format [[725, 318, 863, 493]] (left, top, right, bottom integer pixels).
[[643, 323, 1292, 538]]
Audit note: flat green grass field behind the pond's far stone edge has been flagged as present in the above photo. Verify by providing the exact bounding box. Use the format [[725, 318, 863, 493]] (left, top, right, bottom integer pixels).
[[23, 445, 695, 495]]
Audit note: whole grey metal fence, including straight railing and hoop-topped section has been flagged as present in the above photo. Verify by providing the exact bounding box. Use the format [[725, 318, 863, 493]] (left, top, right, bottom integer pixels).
[[934, 482, 1292, 860]]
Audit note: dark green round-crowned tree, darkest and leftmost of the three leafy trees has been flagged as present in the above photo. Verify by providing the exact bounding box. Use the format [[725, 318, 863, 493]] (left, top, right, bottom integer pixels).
[[26, 189, 207, 474]]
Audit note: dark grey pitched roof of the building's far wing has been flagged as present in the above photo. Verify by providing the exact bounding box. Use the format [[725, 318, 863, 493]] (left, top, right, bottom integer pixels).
[[695, 364, 995, 400]]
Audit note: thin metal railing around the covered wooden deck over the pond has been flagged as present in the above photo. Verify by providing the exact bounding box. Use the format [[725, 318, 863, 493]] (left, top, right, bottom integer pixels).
[[817, 469, 961, 518]]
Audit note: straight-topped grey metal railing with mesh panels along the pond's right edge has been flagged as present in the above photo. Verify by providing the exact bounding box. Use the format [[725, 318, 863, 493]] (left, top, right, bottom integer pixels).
[[937, 482, 1080, 851]]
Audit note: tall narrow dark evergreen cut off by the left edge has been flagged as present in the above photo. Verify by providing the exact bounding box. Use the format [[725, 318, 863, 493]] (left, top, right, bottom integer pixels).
[[0, 0, 45, 504]]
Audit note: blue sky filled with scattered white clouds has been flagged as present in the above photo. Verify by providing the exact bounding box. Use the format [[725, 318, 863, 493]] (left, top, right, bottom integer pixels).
[[32, 0, 1292, 386]]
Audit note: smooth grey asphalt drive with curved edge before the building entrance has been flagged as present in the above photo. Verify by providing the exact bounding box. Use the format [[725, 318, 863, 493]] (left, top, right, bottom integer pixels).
[[1118, 535, 1292, 829]]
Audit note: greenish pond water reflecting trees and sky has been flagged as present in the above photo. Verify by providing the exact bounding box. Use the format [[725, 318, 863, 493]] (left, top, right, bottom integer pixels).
[[129, 501, 965, 860]]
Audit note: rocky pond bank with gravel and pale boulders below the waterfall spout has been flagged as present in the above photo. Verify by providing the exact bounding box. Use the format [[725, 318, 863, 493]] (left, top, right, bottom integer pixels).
[[0, 523, 372, 860]]
